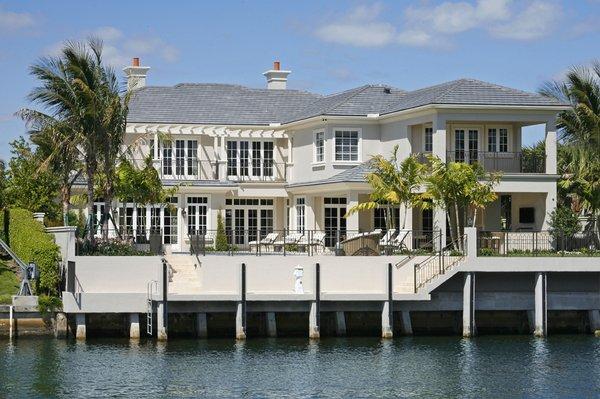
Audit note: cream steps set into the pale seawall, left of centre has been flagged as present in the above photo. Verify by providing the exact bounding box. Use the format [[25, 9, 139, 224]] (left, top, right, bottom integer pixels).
[[165, 254, 200, 295]]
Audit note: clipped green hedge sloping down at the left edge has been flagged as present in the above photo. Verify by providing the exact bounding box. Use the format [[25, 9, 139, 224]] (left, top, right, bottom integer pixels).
[[0, 209, 60, 296]]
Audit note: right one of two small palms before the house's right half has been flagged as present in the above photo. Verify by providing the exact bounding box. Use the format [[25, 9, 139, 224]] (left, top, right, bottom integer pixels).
[[423, 156, 501, 251]]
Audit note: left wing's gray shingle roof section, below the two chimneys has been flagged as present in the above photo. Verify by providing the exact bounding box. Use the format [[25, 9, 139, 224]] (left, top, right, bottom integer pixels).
[[128, 83, 320, 125]]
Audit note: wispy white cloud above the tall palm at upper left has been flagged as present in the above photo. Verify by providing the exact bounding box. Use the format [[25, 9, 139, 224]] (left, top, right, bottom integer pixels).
[[45, 26, 179, 69]]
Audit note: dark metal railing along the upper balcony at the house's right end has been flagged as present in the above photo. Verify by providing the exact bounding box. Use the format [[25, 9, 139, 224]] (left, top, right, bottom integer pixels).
[[446, 150, 545, 173]]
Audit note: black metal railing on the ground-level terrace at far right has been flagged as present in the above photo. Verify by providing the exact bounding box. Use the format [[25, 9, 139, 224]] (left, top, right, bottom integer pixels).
[[477, 231, 600, 256]]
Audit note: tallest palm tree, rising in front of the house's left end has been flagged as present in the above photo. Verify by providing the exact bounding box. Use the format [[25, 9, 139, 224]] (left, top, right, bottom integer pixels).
[[29, 38, 121, 245]]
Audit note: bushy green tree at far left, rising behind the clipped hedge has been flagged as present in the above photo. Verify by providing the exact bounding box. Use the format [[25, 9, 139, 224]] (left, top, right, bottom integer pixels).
[[5, 137, 59, 219]]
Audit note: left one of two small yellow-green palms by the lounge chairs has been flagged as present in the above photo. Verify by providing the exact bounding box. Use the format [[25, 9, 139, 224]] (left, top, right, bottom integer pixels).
[[346, 146, 426, 229]]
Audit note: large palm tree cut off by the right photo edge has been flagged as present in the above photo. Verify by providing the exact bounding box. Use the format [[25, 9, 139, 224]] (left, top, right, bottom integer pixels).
[[540, 61, 600, 230]]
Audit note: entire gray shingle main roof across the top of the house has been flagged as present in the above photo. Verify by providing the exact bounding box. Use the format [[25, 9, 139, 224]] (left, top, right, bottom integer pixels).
[[128, 79, 568, 125]]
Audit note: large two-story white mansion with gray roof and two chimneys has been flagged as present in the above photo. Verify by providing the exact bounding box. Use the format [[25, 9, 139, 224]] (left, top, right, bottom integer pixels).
[[96, 59, 568, 252]]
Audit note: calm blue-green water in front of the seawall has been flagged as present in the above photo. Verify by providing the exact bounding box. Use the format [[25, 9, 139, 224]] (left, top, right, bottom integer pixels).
[[0, 336, 600, 398]]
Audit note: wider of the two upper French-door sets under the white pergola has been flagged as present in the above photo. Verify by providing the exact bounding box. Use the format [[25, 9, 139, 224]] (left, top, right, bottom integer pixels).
[[226, 140, 275, 177]]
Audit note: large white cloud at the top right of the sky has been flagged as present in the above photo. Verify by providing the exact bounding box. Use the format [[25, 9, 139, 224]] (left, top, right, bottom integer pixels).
[[316, 0, 562, 48]]
